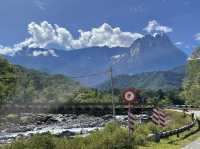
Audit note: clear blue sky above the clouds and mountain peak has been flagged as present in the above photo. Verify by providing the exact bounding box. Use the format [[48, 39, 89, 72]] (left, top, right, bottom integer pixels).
[[0, 0, 200, 53]]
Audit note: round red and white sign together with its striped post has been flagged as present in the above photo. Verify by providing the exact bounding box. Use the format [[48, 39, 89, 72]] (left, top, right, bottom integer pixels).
[[123, 89, 136, 147]]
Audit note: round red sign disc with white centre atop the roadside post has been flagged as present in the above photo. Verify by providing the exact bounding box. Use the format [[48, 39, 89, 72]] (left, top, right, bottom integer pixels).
[[123, 89, 136, 102]]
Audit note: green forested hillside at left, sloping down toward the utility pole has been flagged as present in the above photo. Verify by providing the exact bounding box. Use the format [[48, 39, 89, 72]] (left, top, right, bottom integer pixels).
[[0, 57, 115, 103]]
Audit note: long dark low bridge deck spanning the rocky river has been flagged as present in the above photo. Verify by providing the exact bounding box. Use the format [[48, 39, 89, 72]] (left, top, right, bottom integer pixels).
[[0, 103, 152, 114]]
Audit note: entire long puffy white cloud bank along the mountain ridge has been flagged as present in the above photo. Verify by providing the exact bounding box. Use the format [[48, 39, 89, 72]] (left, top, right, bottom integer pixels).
[[0, 21, 143, 55]]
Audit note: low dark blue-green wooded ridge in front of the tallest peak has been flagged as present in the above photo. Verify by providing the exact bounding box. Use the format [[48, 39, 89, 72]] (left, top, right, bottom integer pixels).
[[97, 66, 185, 90]]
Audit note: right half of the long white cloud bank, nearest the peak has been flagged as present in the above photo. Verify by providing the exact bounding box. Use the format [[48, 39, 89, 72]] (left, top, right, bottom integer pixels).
[[72, 23, 143, 49]]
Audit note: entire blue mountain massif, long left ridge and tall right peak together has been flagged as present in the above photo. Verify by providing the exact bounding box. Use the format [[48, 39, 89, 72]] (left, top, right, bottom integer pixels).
[[7, 33, 187, 86]]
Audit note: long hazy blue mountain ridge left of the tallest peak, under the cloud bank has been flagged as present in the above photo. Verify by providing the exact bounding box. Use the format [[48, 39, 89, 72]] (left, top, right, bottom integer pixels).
[[6, 47, 128, 86]]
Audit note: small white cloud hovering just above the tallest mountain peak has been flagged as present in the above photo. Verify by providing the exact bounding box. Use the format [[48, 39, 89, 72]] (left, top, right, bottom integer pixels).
[[143, 20, 173, 33]]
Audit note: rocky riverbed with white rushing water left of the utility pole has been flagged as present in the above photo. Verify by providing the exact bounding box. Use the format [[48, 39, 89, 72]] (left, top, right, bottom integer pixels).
[[0, 113, 115, 144]]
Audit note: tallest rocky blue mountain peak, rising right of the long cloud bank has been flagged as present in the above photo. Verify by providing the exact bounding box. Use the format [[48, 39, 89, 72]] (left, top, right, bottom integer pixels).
[[112, 33, 187, 74]]
